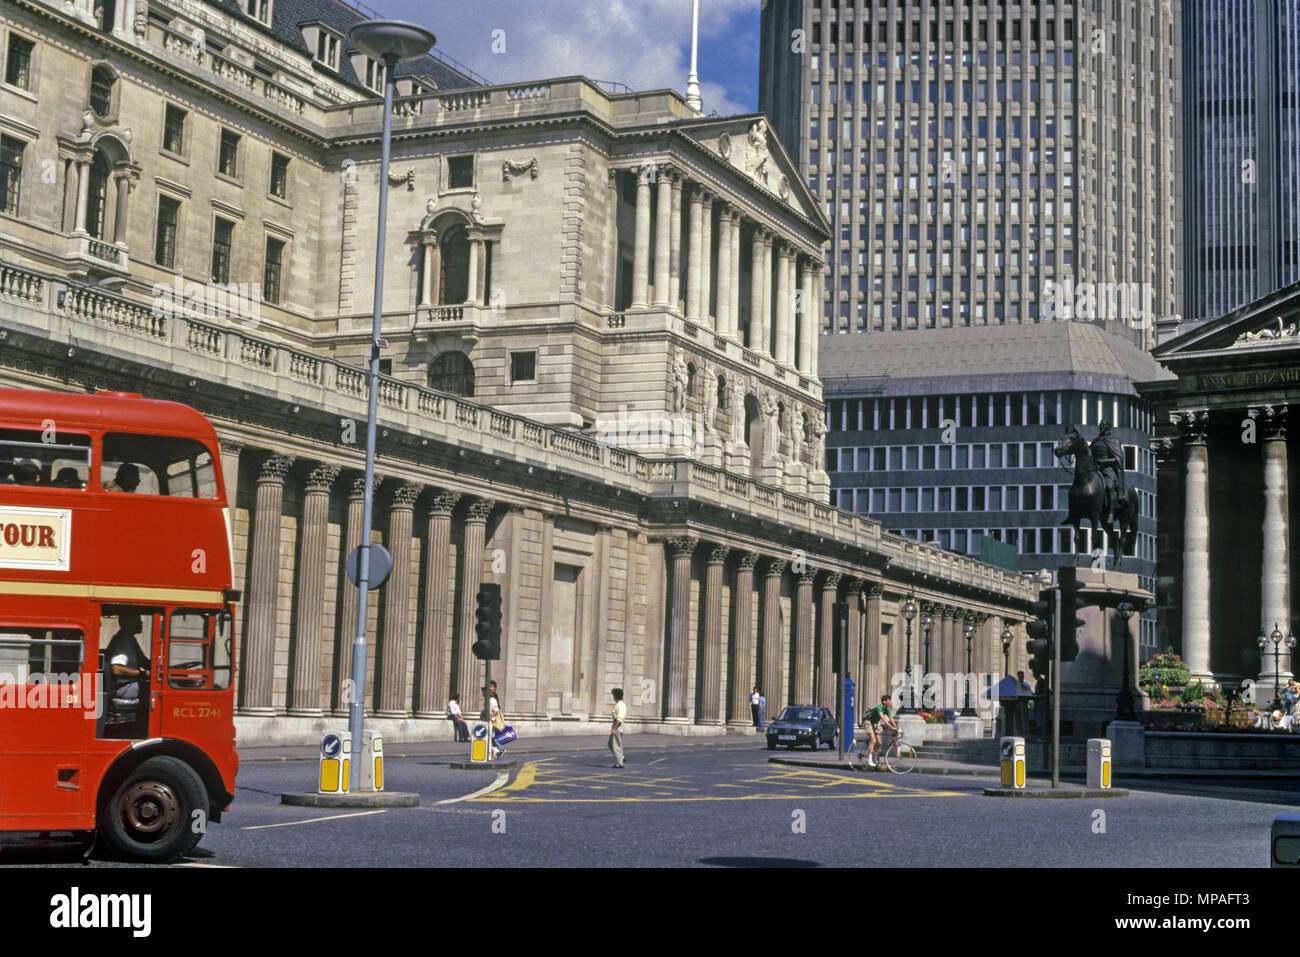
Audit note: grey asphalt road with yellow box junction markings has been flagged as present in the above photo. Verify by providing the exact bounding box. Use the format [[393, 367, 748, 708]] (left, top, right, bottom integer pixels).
[[0, 746, 1300, 867]]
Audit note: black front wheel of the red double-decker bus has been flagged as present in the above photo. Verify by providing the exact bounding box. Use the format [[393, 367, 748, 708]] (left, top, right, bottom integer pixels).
[[100, 755, 208, 862]]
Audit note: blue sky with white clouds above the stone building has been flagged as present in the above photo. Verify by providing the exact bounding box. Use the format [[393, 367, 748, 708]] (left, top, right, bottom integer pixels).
[[367, 0, 763, 114]]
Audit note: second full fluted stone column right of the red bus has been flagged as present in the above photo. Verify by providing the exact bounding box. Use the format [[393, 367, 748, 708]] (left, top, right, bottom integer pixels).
[[289, 464, 339, 715]]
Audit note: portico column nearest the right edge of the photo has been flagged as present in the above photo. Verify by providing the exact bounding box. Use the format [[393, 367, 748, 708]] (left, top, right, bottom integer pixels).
[[1249, 406, 1291, 679]]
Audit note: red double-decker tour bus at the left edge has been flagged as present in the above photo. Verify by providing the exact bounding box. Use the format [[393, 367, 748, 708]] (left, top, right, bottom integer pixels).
[[0, 389, 239, 861]]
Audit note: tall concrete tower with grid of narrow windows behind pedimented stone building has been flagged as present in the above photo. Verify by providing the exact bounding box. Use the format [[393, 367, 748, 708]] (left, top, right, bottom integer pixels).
[[759, 0, 1182, 347]]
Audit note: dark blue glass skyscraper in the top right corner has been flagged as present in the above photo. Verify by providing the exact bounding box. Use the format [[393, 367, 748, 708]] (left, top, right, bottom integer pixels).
[[1183, 0, 1300, 322]]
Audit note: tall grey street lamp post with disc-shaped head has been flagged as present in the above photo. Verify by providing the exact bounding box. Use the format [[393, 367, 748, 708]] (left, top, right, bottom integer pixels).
[[347, 20, 437, 794]]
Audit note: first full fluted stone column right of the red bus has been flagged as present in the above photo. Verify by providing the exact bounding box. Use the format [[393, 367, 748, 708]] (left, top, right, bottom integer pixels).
[[241, 455, 293, 715]]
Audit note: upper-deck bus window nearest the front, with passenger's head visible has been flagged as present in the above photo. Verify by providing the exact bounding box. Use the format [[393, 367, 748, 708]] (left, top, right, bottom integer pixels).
[[100, 433, 217, 498]]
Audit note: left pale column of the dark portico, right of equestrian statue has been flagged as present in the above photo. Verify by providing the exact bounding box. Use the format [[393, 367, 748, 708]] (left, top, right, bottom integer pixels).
[[1171, 408, 1213, 680]]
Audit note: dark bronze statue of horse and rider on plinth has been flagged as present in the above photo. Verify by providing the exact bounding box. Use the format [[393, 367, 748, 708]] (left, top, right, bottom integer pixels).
[[1052, 423, 1138, 571]]
